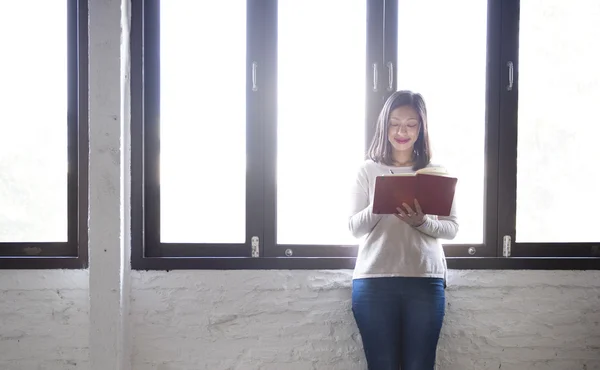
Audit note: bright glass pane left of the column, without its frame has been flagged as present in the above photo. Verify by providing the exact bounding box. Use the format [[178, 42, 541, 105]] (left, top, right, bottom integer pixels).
[[0, 1, 68, 242]]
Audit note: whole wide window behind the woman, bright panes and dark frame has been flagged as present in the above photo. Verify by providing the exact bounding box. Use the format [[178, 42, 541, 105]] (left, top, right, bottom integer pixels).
[[132, 0, 600, 269]]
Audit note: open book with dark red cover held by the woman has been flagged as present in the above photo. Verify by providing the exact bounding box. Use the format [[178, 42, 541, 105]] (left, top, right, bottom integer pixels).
[[373, 167, 458, 216]]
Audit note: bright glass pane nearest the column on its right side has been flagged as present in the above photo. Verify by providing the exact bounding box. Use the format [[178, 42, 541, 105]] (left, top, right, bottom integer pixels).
[[160, 0, 246, 243]]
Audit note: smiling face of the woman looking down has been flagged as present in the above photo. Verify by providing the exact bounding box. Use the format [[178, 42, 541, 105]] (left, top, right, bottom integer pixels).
[[388, 105, 421, 152]]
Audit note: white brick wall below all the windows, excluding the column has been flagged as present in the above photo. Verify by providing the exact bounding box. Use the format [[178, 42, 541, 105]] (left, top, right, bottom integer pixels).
[[0, 271, 600, 370]]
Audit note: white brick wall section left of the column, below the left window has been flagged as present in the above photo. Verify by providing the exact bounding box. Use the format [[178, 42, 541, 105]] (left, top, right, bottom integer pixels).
[[0, 270, 90, 370]]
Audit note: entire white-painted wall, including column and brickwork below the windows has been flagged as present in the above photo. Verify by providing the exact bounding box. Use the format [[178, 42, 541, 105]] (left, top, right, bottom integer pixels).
[[0, 0, 600, 370]]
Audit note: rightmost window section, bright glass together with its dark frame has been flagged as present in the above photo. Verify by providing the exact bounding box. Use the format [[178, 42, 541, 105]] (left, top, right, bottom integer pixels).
[[499, 0, 600, 266]]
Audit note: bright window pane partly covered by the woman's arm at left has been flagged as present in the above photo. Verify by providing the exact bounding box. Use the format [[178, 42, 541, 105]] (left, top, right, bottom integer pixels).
[[277, 0, 366, 244]]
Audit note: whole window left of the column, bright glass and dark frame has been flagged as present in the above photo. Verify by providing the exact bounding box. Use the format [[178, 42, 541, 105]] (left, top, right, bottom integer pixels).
[[0, 0, 87, 269]]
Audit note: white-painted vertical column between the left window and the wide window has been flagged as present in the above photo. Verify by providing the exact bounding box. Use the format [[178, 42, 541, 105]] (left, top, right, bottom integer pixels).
[[88, 0, 131, 370]]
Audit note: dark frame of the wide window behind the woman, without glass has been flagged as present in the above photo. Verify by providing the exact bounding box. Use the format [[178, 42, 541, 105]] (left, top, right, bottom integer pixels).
[[131, 0, 600, 270]]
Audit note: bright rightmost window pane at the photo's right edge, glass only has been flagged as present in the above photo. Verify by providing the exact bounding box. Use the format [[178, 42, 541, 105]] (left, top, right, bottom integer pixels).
[[516, 0, 600, 242]]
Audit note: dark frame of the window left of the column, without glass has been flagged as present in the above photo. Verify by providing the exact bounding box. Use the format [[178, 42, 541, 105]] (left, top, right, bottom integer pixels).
[[0, 0, 88, 269]]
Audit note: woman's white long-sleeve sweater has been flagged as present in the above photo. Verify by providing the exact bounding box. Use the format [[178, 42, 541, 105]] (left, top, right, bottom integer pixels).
[[348, 160, 458, 279]]
